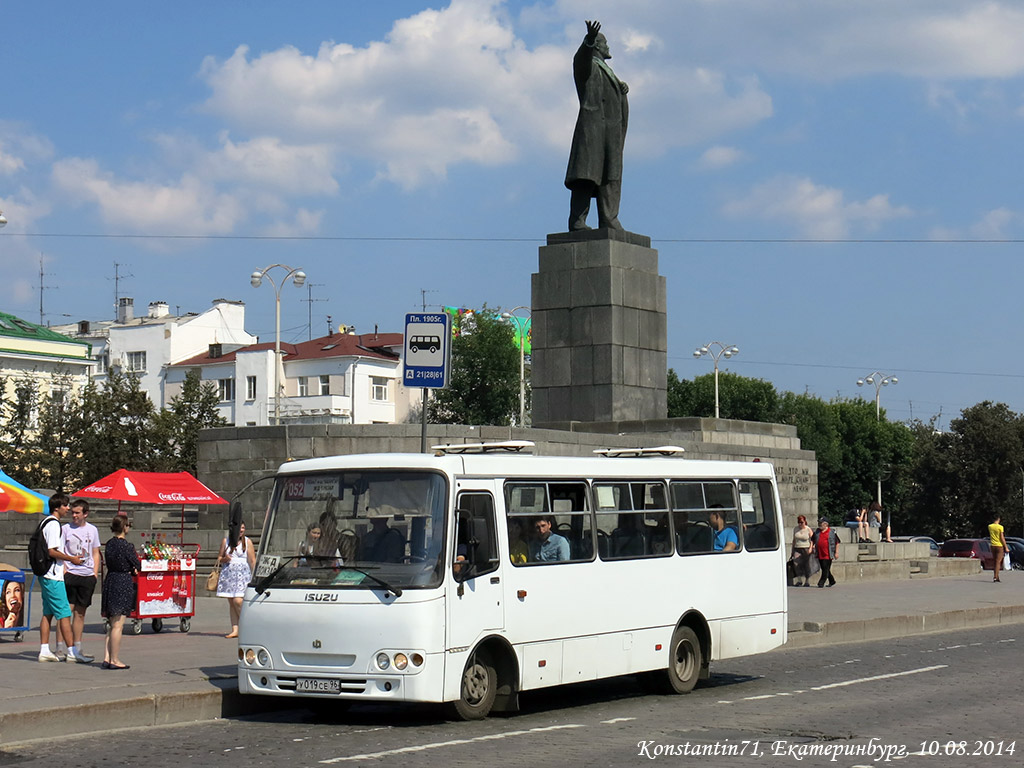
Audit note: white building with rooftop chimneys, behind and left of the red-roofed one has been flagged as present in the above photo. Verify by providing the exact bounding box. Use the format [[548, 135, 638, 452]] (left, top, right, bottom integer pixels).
[[51, 297, 258, 409]]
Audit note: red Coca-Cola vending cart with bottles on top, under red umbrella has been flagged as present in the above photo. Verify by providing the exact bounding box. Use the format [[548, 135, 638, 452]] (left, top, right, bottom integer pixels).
[[128, 543, 200, 635]]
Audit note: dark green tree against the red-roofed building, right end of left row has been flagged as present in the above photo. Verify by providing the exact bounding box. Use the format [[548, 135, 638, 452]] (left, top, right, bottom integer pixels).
[[154, 370, 227, 474]]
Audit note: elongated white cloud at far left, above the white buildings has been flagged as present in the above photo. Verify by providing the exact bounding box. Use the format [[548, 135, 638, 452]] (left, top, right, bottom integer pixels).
[[53, 158, 246, 234]]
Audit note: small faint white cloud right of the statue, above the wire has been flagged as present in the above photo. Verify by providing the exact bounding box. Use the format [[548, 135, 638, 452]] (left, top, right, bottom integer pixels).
[[723, 176, 912, 240]]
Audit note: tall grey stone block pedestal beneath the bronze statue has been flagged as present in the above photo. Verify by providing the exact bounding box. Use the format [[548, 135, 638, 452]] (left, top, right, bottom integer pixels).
[[531, 229, 668, 426]]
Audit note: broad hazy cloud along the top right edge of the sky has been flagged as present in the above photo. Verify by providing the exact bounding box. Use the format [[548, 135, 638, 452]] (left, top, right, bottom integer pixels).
[[558, 0, 1024, 80]]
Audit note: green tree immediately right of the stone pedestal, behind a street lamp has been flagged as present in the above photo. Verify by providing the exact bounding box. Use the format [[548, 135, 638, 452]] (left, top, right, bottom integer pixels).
[[667, 369, 779, 422]]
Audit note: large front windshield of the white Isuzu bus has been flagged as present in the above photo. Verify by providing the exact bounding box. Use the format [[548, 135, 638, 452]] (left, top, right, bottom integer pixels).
[[253, 470, 447, 590]]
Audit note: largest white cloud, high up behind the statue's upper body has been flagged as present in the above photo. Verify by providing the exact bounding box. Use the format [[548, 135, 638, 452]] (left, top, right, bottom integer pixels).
[[195, 0, 772, 188]]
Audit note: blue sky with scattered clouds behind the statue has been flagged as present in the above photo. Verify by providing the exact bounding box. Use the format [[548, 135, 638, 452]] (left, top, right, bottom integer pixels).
[[0, 0, 1024, 428]]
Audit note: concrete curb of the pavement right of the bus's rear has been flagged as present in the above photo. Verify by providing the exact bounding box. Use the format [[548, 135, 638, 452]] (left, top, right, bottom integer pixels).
[[782, 605, 1024, 648]]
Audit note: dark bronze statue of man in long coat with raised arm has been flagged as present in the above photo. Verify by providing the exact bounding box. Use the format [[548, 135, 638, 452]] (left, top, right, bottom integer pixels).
[[565, 22, 630, 231]]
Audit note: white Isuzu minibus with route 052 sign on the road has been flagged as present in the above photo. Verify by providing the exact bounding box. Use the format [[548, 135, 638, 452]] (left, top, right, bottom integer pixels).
[[239, 441, 786, 719]]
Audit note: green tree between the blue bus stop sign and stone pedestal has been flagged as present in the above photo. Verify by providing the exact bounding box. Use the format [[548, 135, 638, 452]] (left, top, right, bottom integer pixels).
[[427, 307, 519, 426]]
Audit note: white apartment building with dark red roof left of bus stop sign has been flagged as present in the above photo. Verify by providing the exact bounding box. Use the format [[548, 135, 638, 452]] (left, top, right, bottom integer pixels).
[[164, 333, 411, 427]]
